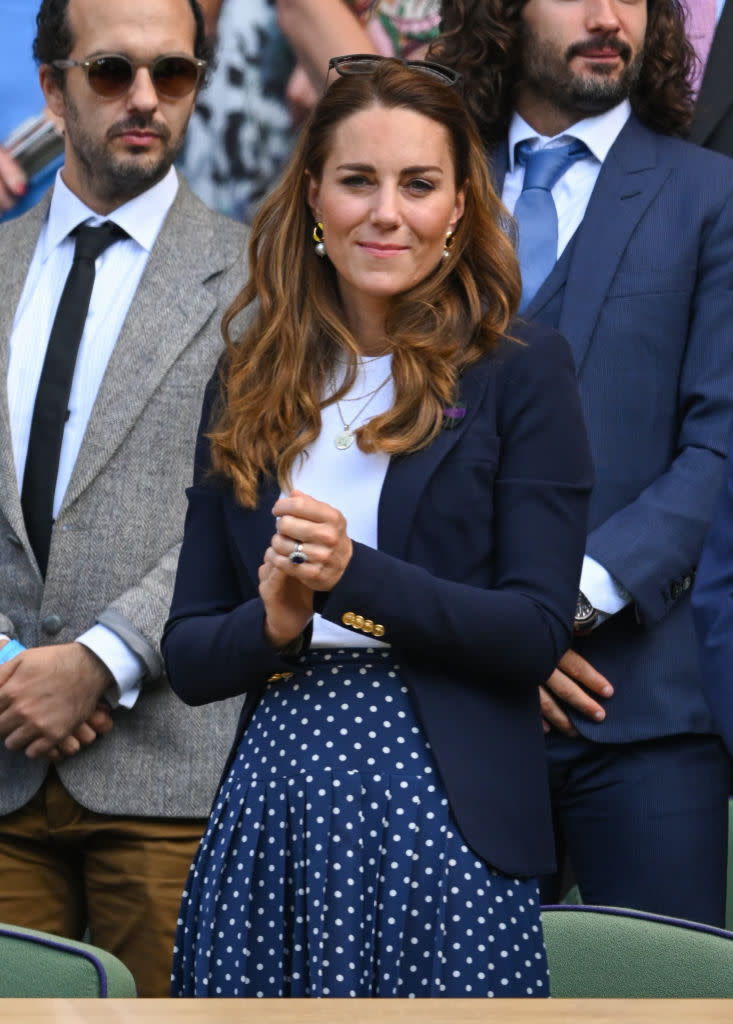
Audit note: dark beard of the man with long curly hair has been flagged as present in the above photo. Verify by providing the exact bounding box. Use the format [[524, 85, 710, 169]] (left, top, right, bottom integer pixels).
[[522, 25, 644, 117]]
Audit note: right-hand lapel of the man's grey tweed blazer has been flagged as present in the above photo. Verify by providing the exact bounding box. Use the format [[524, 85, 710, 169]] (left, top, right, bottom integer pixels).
[[63, 181, 239, 506]]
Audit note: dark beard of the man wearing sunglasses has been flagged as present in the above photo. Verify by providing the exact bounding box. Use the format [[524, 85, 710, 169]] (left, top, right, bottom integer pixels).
[[64, 91, 185, 205]]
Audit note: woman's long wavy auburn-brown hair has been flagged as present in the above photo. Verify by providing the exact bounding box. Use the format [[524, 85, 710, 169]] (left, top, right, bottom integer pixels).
[[209, 59, 521, 507]]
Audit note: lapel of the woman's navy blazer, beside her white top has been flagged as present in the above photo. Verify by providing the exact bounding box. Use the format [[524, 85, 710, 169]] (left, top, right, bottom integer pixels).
[[377, 359, 490, 558]]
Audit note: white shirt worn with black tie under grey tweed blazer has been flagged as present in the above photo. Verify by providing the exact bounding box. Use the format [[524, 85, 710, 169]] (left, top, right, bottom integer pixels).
[[7, 168, 178, 707]]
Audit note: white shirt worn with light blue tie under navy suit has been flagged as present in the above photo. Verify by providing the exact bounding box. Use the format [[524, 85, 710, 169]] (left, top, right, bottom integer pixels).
[[502, 99, 632, 625]]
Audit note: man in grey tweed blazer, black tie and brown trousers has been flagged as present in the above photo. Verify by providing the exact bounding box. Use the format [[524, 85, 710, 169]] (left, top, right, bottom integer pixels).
[[0, 0, 246, 995]]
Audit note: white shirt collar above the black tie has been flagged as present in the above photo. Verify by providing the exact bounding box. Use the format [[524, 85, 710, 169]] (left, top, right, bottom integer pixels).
[[41, 167, 178, 262]]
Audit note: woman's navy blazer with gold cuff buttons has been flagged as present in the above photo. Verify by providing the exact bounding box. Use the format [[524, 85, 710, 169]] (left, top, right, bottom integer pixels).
[[163, 328, 592, 874]]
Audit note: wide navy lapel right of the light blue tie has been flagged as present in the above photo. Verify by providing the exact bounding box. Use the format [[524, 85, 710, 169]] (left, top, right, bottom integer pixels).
[[559, 115, 671, 371]]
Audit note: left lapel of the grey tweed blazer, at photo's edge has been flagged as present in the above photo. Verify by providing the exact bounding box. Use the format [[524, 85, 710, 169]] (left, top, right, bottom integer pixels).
[[0, 193, 50, 541]]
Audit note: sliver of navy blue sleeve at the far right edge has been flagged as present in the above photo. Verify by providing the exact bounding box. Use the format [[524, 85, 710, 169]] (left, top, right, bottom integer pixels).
[[692, 419, 733, 755]]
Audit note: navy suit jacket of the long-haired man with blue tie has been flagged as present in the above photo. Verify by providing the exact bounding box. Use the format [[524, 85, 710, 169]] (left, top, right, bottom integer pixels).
[[497, 116, 733, 742]]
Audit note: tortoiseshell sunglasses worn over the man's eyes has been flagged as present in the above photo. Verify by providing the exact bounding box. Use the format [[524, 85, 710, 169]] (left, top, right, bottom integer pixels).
[[51, 53, 206, 99]]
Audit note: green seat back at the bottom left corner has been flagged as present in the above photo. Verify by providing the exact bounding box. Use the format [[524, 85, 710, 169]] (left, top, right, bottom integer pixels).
[[0, 925, 137, 998]]
